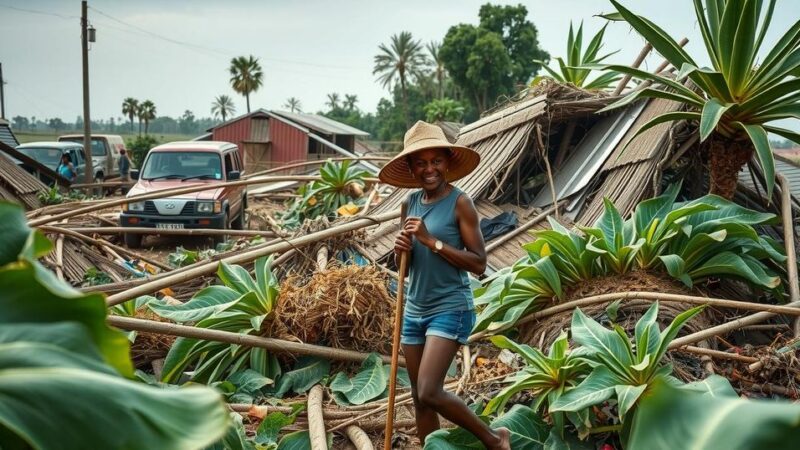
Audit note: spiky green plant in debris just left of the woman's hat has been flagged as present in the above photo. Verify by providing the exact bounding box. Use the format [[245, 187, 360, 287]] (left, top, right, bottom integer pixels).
[[281, 161, 369, 228]]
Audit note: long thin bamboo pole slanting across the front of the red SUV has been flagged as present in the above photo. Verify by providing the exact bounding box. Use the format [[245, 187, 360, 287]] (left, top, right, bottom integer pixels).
[[28, 175, 378, 227]]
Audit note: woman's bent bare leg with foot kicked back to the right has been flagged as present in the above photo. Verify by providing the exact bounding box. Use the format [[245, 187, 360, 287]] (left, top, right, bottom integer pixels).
[[416, 336, 511, 450]]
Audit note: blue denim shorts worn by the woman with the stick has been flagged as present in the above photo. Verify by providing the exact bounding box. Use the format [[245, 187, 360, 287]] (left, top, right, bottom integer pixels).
[[400, 310, 475, 345]]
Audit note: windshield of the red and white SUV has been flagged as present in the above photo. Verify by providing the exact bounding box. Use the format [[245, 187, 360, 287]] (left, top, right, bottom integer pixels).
[[141, 152, 222, 180]]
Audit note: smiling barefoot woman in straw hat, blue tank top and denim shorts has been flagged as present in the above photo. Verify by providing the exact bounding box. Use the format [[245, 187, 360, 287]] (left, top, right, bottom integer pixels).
[[380, 121, 511, 450]]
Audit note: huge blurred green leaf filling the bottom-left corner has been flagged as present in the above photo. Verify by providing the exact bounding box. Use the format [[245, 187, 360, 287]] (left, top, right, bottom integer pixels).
[[0, 367, 229, 450]]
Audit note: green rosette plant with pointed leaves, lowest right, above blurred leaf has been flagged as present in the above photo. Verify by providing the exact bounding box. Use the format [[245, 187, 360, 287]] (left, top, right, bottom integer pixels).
[[550, 302, 705, 418]]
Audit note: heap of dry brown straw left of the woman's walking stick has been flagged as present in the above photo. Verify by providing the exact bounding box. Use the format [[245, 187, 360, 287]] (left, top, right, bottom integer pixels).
[[270, 265, 394, 354]]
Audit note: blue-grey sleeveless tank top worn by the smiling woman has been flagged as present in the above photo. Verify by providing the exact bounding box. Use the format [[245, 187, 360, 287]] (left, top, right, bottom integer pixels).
[[405, 186, 474, 316]]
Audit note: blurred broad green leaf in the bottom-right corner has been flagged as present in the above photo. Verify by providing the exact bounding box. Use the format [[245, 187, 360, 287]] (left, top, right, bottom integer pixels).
[[626, 376, 800, 450]]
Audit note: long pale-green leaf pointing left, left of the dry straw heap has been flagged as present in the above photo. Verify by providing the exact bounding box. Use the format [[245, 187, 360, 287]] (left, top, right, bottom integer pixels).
[[148, 286, 242, 322]]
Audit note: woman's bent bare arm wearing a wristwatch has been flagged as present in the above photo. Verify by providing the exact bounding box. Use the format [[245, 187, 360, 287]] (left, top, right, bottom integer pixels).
[[405, 194, 486, 275]]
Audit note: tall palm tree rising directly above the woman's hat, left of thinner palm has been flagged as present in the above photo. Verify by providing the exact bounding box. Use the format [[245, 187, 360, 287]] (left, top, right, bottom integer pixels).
[[372, 31, 427, 126]]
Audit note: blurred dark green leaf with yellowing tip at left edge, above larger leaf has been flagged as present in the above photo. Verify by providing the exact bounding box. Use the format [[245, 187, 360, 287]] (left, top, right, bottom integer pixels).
[[0, 261, 133, 376]]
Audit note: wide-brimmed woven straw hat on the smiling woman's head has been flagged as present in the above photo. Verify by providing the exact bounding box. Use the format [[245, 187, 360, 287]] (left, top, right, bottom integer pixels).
[[378, 120, 481, 188]]
